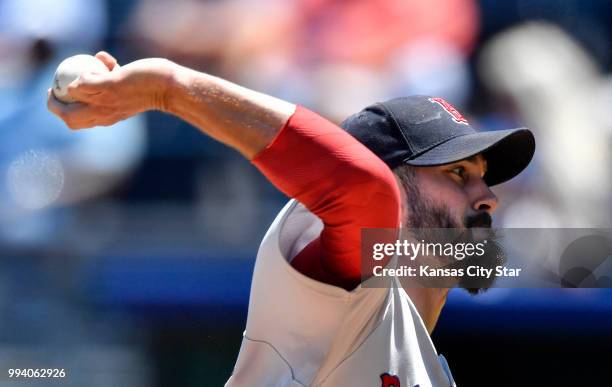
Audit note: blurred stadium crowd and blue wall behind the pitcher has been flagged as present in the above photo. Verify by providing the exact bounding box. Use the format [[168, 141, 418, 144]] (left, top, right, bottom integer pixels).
[[0, 0, 612, 387]]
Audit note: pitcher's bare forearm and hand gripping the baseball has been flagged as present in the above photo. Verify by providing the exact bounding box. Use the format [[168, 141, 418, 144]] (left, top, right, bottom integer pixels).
[[47, 52, 295, 152]]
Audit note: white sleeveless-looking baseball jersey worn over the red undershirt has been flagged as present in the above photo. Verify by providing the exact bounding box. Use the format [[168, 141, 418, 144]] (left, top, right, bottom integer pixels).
[[226, 200, 455, 387]]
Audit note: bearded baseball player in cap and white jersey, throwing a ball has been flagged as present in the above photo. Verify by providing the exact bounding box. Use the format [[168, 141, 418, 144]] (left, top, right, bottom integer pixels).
[[48, 52, 535, 387]]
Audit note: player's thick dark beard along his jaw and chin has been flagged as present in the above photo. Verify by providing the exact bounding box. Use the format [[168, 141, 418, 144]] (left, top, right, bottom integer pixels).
[[399, 167, 506, 295]]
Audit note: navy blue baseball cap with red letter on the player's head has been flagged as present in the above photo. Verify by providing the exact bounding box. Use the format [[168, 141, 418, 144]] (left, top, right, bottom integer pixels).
[[340, 95, 535, 186]]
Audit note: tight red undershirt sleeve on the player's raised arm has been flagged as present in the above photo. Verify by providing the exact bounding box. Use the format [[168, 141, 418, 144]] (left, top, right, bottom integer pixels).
[[252, 106, 400, 289]]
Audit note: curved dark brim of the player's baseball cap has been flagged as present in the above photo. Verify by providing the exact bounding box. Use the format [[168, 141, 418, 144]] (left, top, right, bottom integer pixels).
[[404, 128, 535, 186]]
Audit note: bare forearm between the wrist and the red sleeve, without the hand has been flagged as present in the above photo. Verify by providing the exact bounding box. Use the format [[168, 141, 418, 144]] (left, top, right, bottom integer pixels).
[[160, 64, 295, 160]]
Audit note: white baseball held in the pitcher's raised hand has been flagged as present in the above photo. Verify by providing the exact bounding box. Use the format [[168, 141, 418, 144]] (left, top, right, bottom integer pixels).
[[53, 54, 109, 103]]
